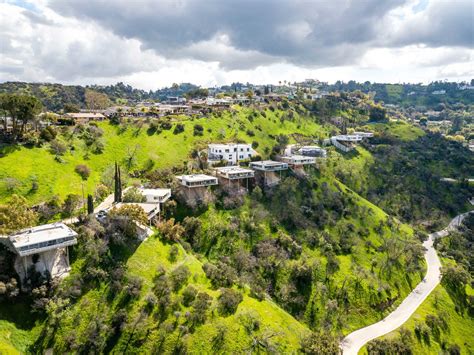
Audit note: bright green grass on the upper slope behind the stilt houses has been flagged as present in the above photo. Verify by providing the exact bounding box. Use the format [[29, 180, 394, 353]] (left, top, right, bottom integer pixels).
[[0, 108, 325, 204]]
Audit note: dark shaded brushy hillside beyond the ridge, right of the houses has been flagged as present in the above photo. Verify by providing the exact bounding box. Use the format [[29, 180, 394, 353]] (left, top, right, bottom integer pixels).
[[334, 122, 474, 228]]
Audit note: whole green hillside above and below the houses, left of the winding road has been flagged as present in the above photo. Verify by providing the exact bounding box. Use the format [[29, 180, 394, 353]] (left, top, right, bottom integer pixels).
[[0, 98, 472, 353]]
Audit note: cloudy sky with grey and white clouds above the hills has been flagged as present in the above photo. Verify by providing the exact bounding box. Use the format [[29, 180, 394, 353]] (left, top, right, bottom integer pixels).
[[0, 0, 474, 90]]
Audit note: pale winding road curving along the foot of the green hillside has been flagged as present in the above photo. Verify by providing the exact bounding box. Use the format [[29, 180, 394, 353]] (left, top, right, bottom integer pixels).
[[341, 211, 474, 355]]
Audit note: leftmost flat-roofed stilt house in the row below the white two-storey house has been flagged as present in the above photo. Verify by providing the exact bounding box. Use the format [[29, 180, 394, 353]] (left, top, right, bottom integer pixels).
[[176, 174, 219, 207]]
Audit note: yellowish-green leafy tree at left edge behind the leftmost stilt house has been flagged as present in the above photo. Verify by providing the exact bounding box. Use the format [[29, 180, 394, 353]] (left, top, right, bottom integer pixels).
[[0, 195, 38, 234]]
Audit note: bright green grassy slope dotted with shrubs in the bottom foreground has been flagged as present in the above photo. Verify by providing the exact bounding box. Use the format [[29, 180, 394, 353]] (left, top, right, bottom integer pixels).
[[30, 236, 309, 353]]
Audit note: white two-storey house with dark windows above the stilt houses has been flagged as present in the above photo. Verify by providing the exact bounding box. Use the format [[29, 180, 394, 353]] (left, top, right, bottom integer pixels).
[[207, 143, 257, 165]]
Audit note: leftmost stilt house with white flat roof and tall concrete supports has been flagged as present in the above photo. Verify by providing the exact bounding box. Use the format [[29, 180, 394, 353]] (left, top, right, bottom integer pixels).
[[8, 223, 77, 282]]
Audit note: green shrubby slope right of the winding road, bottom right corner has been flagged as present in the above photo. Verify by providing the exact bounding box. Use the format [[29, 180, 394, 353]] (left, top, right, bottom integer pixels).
[[361, 215, 474, 354]]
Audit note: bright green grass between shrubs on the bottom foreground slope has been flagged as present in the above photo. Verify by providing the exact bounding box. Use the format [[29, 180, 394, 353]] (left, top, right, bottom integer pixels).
[[37, 236, 309, 353]]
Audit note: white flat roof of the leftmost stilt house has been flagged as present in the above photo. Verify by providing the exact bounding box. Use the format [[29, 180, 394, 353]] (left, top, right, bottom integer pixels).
[[9, 222, 77, 249]]
